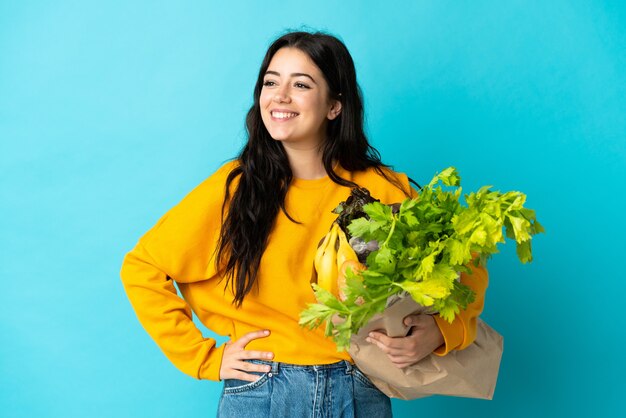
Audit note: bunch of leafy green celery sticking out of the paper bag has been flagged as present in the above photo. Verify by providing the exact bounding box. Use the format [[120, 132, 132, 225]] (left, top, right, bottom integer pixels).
[[300, 167, 544, 350]]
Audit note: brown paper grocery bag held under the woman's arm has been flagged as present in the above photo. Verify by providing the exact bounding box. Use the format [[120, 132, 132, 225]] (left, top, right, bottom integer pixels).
[[350, 297, 503, 399]]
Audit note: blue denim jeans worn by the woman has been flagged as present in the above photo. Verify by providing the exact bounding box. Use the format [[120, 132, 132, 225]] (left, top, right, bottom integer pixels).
[[217, 360, 391, 418]]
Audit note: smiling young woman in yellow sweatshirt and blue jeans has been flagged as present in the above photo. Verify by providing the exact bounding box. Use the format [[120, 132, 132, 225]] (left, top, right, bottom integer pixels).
[[121, 32, 486, 417]]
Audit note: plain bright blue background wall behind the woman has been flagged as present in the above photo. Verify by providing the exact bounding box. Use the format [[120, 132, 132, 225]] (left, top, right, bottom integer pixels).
[[0, 0, 626, 417]]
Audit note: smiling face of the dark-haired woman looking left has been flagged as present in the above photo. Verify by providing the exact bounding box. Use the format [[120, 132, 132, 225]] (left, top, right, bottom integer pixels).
[[259, 47, 341, 149]]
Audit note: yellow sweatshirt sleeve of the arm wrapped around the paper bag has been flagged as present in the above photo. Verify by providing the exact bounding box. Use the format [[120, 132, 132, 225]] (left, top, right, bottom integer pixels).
[[434, 263, 489, 356]]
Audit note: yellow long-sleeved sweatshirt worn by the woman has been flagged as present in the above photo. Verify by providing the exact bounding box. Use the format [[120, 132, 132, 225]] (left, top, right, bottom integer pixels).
[[121, 161, 487, 380]]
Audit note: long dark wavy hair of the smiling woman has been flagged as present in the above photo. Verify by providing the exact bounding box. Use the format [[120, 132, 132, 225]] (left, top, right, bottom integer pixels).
[[216, 31, 409, 306]]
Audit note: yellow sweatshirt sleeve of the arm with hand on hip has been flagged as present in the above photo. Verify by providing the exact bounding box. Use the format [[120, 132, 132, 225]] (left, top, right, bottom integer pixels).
[[120, 161, 238, 380]]
